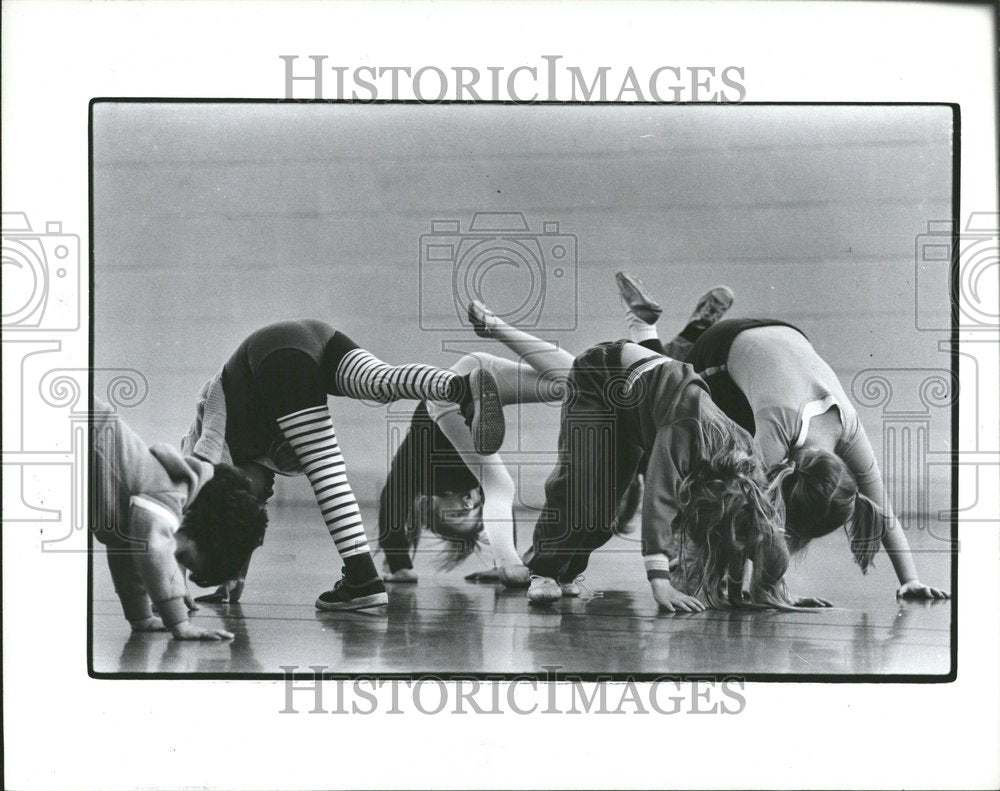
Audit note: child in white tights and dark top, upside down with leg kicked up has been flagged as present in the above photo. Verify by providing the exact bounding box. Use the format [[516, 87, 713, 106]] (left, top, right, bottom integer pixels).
[[379, 284, 725, 596]]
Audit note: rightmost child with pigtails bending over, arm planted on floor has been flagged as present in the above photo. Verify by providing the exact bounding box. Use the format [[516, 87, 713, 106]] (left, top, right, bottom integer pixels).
[[623, 276, 949, 599]]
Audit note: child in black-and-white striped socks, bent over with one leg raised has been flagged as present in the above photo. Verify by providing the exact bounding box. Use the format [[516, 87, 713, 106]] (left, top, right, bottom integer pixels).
[[184, 320, 504, 610]]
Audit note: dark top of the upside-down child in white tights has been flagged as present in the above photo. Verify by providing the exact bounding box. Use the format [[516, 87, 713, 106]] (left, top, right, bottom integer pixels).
[[378, 401, 479, 571]]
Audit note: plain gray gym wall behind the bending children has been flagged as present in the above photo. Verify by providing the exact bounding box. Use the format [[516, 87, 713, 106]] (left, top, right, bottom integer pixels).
[[93, 103, 952, 508]]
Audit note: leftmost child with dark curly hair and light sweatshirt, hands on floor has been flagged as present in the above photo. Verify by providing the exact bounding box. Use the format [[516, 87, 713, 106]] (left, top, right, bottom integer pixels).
[[88, 400, 267, 640]]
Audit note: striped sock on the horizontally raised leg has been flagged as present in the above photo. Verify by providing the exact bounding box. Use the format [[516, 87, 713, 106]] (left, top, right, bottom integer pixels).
[[334, 349, 458, 404]]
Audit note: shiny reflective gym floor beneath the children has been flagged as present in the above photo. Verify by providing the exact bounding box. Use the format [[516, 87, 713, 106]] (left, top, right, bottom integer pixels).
[[93, 504, 951, 676]]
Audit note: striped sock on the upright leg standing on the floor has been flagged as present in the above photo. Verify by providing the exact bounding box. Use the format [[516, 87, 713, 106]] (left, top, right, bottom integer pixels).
[[278, 405, 375, 582]]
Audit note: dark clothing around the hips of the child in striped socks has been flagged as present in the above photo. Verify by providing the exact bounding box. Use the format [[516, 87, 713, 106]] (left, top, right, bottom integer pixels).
[[222, 319, 358, 463]]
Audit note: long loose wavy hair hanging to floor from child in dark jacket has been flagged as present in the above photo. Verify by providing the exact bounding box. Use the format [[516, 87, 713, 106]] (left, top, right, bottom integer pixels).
[[673, 421, 795, 610]]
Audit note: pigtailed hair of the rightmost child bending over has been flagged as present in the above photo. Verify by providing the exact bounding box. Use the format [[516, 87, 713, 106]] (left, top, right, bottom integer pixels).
[[768, 448, 887, 573]]
